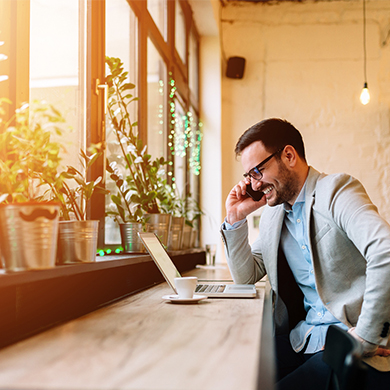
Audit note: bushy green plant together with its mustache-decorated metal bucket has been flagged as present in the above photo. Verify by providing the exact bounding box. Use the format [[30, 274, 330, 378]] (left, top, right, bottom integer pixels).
[[0, 99, 64, 271]]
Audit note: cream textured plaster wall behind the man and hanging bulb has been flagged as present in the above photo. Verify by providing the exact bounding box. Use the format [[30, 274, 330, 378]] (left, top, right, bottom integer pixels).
[[221, 0, 390, 221]]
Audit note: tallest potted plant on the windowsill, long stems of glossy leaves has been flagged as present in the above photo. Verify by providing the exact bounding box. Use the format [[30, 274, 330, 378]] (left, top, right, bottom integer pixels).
[[106, 57, 171, 245]]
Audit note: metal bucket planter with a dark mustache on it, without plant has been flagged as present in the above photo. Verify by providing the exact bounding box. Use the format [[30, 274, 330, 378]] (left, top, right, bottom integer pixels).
[[0, 202, 60, 272]]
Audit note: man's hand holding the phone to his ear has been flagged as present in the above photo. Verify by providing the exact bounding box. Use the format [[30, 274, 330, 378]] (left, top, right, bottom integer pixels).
[[226, 180, 267, 225]]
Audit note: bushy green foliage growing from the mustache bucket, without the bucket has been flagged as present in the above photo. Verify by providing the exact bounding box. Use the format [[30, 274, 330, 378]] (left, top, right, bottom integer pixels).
[[0, 98, 65, 203]]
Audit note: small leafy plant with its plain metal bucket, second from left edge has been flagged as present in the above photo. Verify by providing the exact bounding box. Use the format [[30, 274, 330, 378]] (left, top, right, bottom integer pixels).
[[51, 145, 108, 264]]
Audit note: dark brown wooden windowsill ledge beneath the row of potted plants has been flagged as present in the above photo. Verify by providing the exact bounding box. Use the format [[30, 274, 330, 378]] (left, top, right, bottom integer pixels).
[[0, 249, 205, 348]]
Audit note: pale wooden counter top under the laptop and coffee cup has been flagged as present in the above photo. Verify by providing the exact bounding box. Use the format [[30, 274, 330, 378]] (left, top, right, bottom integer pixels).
[[0, 269, 264, 390]]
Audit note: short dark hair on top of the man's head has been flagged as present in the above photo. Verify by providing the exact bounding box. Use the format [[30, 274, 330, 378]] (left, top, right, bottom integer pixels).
[[234, 118, 306, 161]]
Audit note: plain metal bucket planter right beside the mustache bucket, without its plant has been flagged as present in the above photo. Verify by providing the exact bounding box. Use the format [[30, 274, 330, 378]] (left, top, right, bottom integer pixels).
[[57, 220, 99, 264]]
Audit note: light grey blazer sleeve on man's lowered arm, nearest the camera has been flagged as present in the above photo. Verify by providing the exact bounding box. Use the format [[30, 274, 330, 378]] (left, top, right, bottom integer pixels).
[[316, 174, 390, 345]]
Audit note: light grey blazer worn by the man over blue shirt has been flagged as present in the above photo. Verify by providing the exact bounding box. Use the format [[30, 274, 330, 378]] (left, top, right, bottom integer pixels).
[[221, 167, 390, 371]]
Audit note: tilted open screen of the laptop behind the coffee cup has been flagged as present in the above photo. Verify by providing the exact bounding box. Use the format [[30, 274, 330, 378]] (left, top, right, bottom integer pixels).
[[138, 233, 181, 291]]
